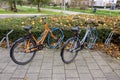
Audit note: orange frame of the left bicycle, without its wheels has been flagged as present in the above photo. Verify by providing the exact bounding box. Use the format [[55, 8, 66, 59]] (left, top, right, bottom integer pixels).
[[25, 23, 57, 52]]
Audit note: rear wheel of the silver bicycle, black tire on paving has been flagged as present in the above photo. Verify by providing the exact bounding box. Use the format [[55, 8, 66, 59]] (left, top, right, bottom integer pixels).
[[61, 37, 78, 64]]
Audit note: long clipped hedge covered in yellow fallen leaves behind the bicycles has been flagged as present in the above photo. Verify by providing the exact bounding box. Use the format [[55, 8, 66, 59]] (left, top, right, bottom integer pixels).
[[0, 15, 120, 45]]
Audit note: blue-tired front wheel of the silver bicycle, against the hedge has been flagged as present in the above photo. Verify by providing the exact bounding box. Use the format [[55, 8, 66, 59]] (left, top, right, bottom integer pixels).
[[86, 28, 98, 49]]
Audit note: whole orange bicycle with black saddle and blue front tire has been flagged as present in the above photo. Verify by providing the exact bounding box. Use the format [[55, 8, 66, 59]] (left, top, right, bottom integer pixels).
[[10, 18, 64, 65]]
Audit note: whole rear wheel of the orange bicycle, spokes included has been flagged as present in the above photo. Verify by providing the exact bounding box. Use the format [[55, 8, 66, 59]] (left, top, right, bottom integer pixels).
[[10, 38, 36, 65]]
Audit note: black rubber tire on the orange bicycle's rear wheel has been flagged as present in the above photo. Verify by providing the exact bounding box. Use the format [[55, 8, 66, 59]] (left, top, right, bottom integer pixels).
[[10, 38, 36, 65]]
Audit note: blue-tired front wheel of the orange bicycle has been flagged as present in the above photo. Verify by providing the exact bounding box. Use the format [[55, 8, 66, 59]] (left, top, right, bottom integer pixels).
[[47, 28, 64, 48]]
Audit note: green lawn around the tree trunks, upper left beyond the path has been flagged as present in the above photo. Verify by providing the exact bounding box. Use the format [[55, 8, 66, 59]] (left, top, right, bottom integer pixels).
[[0, 6, 62, 15]]
